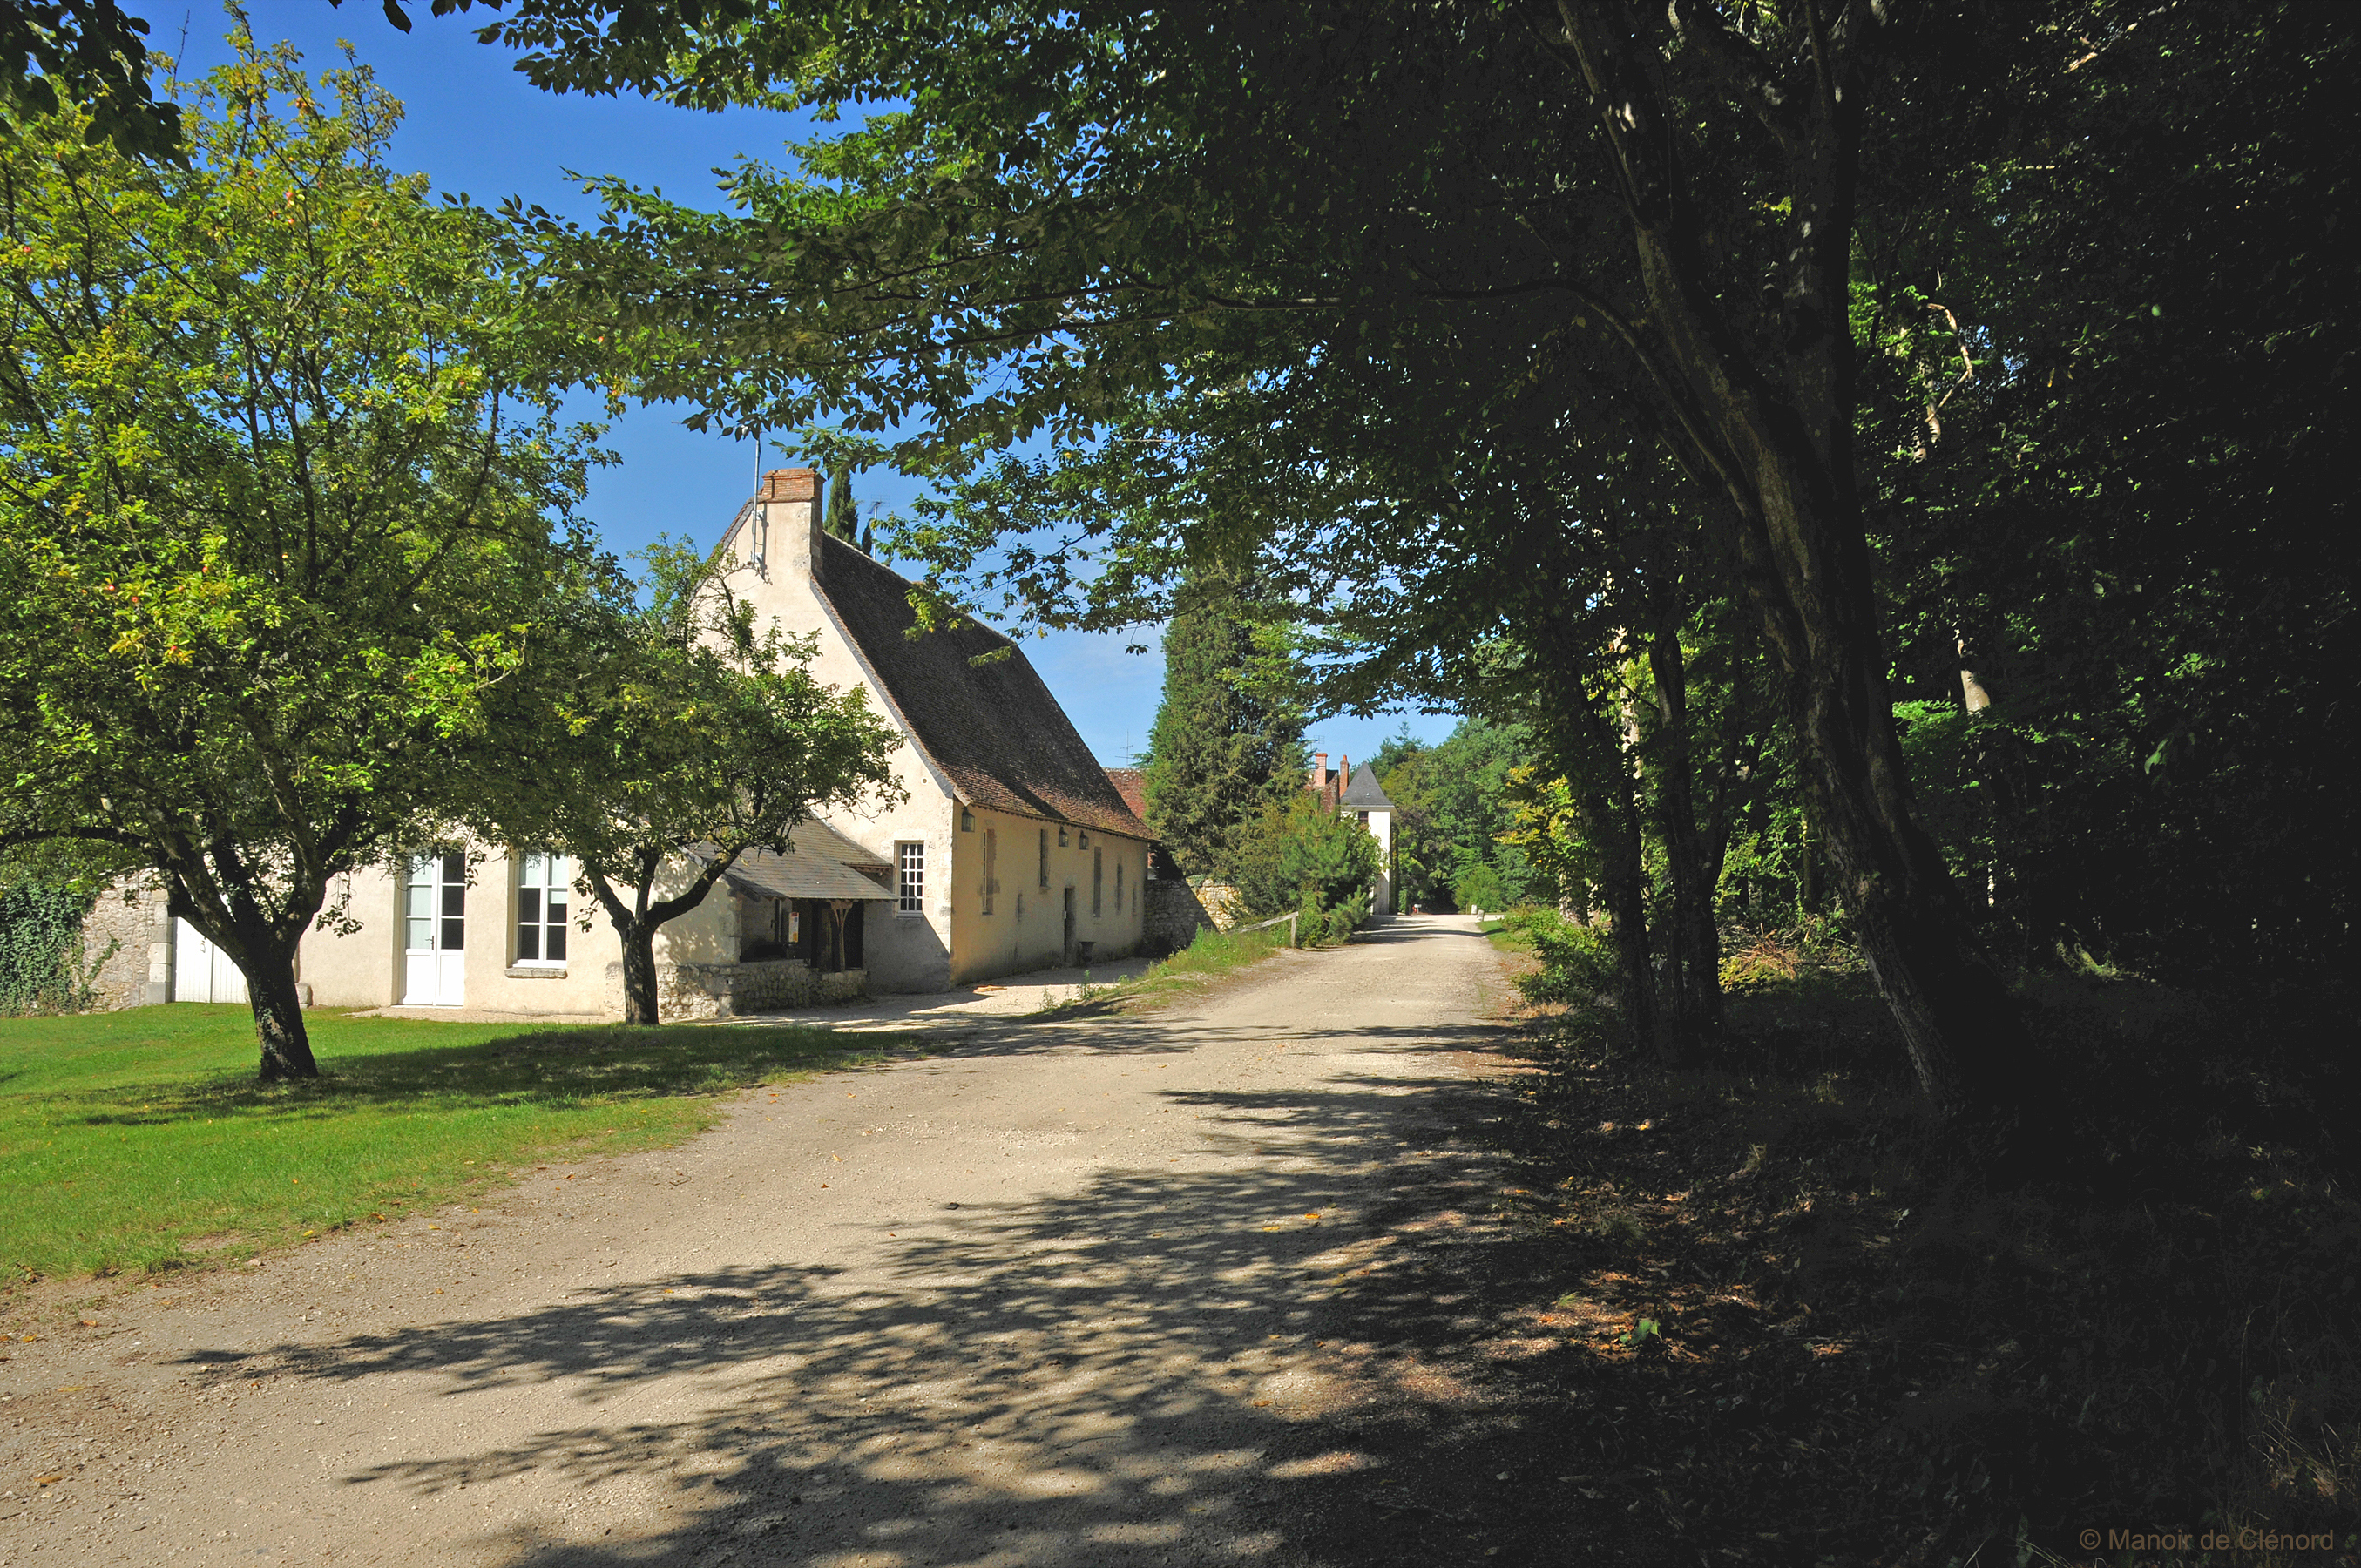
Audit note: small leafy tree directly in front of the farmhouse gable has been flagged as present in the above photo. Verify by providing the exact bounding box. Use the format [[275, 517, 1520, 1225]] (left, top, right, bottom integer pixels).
[[484, 541, 900, 1025]]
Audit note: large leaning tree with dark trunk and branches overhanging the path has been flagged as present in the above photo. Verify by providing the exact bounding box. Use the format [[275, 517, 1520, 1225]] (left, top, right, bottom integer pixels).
[[498, 0, 2045, 1107]]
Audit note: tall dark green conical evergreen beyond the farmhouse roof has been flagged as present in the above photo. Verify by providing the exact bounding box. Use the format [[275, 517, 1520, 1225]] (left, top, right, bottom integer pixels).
[[1145, 576, 1303, 876]]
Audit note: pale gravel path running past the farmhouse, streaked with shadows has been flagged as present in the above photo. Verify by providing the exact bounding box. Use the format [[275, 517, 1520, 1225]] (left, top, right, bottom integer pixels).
[[0, 916, 1539, 1568]]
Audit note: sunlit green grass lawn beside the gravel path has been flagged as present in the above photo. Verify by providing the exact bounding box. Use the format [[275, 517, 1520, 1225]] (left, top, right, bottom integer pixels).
[[0, 1004, 876, 1280]]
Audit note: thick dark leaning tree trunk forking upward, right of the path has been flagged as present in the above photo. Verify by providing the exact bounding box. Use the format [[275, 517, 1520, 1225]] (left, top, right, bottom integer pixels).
[[1559, 0, 2028, 1115]]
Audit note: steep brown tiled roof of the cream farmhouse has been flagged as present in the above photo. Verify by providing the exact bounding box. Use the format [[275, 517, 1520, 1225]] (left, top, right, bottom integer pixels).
[[817, 536, 1147, 838]]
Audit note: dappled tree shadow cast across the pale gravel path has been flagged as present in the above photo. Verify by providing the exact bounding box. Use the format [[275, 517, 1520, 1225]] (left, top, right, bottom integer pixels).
[[171, 1030, 1629, 1568]]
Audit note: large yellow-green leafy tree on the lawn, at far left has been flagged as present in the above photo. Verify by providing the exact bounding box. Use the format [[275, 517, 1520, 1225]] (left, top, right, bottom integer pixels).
[[0, 43, 592, 1079]]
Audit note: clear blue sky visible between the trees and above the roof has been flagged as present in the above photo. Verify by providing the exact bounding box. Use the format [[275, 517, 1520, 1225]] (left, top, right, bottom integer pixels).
[[161, 0, 1454, 765]]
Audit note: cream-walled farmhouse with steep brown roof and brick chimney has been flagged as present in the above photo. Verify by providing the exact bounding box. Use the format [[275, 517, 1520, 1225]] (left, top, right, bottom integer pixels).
[[125, 468, 1150, 1017]]
